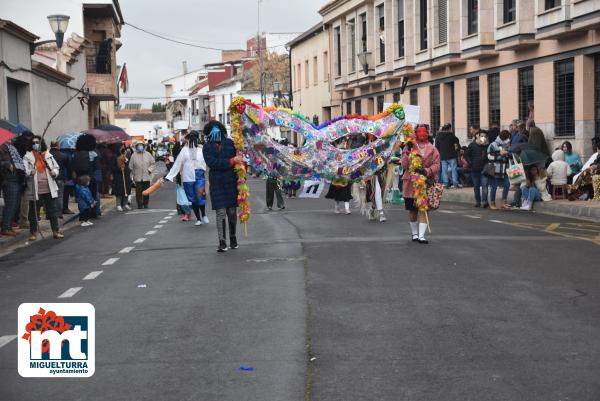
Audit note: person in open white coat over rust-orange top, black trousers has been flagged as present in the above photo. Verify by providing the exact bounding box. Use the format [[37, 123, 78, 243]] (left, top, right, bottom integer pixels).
[[23, 135, 64, 241]]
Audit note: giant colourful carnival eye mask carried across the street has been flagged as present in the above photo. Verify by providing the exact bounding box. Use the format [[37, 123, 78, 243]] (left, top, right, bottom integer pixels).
[[230, 97, 412, 223]]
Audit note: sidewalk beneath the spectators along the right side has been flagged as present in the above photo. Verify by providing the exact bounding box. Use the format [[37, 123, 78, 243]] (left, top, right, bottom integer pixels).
[[442, 187, 600, 223]]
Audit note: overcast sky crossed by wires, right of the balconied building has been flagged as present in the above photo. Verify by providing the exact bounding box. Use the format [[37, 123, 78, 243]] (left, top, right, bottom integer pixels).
[[117, 0, 327, 105]]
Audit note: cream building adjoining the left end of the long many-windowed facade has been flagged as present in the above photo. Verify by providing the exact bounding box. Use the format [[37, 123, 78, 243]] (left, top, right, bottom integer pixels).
[[288, 23, 340, 128]]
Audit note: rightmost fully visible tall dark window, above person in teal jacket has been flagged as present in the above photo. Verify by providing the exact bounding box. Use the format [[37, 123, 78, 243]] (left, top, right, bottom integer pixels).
[[554, 59, 575, 136]]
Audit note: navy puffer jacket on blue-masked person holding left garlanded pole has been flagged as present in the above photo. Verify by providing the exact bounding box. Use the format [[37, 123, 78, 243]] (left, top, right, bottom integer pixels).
[[202, 138, 237, 210]]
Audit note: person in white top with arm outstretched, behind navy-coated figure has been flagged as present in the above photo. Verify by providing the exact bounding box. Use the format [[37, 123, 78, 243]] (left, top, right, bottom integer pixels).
[[165, 131, 209, 226]]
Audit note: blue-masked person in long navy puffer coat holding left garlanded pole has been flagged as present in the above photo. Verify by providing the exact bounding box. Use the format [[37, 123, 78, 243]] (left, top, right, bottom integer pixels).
[[202, 121, 239, 252]]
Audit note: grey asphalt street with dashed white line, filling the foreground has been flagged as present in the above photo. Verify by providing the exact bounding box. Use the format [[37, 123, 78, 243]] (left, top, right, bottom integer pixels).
[[0, 181, 600, 401]]
